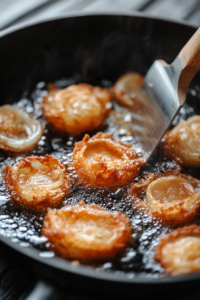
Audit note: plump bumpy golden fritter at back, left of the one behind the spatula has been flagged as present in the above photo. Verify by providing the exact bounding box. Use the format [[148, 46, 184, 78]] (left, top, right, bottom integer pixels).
[[43, 83, 111, 135]]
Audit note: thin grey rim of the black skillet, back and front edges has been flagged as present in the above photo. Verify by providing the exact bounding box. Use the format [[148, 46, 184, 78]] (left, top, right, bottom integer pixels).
[[0, 11, 200, 285]]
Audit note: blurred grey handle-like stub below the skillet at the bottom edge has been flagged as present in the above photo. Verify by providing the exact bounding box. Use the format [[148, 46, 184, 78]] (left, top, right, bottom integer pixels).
[[25, 280, 56, 300]]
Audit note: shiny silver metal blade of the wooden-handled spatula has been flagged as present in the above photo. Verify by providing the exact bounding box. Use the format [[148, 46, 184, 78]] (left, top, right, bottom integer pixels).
[[132, 57, 182, 159]]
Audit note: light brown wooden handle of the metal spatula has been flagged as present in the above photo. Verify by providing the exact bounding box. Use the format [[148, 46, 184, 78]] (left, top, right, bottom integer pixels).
[[178, 28, 200, 101]]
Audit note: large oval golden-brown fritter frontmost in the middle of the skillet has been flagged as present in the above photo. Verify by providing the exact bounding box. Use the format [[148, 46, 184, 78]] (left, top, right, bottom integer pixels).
[[42, 201, 131, 263]]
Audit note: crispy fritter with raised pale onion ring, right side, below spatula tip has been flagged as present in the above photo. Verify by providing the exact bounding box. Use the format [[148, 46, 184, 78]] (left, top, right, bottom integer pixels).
[[129, 169, 200, 225]]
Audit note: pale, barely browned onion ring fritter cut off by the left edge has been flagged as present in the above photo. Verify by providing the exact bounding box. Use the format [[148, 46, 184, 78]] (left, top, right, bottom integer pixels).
[[0, 105, 43, 152]]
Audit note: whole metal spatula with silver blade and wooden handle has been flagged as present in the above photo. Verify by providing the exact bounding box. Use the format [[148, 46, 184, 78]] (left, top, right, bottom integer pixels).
[[132, 28, 200, 159]]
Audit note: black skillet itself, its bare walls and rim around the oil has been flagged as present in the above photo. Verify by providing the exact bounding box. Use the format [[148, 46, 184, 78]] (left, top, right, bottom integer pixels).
[[0, 13, 200, 298]]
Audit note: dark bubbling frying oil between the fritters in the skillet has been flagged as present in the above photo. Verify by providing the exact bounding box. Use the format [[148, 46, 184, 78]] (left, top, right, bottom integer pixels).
[[0, 78, 200, 278]]
